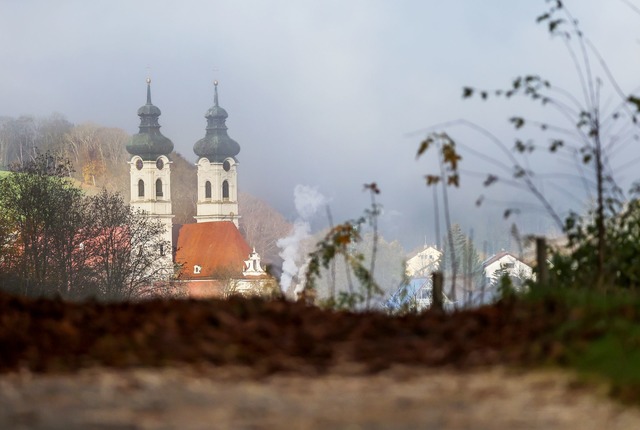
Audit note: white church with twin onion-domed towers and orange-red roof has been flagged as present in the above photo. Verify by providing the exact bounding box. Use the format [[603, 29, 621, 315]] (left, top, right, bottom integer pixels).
[[126, 79, 278, 298]]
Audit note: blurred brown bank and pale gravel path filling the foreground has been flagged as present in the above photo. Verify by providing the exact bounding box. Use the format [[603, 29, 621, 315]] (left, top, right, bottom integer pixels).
[[0, 294, 640, 430]]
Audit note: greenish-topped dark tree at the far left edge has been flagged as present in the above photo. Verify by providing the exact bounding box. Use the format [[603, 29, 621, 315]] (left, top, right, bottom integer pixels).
[[0, 153, 85, 296]]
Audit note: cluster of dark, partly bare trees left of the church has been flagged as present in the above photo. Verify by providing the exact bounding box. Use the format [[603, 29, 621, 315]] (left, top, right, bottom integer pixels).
[[0, 153, 173, 300]]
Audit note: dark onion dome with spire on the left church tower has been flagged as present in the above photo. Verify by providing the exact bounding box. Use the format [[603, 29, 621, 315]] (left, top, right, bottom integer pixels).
[[127, 78, 173, 160]]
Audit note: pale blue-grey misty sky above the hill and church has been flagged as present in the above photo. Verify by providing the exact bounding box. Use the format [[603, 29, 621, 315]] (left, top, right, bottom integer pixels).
[[0, 0, 640, 249]]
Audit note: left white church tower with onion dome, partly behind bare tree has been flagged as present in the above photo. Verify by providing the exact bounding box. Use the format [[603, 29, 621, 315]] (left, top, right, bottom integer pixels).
[[126, 78, 173, 255]]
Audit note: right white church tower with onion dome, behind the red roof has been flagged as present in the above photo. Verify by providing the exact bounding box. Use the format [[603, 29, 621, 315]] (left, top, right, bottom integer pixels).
[[193, 81, 240, 227]]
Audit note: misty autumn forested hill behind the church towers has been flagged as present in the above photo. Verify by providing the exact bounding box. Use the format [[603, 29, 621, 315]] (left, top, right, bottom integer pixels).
[[0, 113, 291, 264]]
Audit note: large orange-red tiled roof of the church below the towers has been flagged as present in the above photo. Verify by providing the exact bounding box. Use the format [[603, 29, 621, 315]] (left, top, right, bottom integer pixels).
[[174, 221, 251, 279]]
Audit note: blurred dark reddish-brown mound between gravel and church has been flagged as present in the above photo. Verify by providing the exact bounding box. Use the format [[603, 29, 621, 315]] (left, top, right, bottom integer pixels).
[[0, 294, 560, 374]]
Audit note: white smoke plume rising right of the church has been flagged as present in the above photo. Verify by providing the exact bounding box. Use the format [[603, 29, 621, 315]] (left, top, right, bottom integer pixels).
[[276, 185, 328, 293]]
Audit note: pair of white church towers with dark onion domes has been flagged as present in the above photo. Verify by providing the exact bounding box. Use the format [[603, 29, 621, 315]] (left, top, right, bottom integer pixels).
[[126, 79, 240, 252]]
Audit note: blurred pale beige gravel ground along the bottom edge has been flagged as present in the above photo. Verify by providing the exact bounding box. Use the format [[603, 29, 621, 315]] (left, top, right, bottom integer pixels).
[[0, 366, 640, 430]]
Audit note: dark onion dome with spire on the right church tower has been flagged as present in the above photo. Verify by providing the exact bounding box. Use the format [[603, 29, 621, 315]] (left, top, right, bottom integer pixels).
[[193, 81, 240, 163]]
